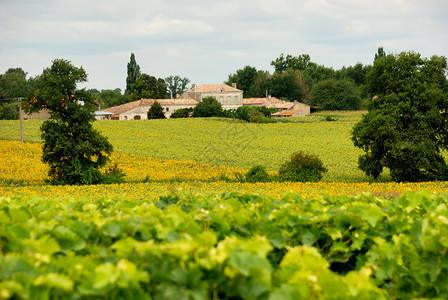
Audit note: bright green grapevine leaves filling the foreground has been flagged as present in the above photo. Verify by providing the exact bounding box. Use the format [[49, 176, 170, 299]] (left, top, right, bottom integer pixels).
[[0, 193, 448, 300]]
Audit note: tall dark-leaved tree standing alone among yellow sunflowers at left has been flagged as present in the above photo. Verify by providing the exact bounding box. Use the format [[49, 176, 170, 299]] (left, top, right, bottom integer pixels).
[[23, 59, 119, 184]]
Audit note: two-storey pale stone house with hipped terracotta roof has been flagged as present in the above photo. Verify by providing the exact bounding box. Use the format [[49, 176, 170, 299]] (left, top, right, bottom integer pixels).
[[182, 83, 243, 109]]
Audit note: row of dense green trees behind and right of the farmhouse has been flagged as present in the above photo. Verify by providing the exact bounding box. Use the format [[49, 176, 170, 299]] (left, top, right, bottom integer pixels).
[[226, 48, 376, 110]]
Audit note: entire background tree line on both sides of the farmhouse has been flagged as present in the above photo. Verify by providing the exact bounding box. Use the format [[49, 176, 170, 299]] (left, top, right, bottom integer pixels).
[[0, 48, 385, 119]]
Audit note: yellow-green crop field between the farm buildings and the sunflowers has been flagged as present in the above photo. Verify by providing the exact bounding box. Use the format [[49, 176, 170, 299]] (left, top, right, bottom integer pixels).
[[0, 112, 388, 182]]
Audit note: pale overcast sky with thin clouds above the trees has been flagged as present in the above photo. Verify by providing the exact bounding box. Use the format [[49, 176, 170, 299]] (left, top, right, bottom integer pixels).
[[0, 0, 448, 91]]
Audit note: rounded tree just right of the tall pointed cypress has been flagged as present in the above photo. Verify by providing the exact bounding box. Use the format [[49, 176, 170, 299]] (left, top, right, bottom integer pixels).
[[130, 73, 167, 100]]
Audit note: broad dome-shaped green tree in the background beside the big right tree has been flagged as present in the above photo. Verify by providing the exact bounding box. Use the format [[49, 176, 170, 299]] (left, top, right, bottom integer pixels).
[[309, 78, 361, 110]]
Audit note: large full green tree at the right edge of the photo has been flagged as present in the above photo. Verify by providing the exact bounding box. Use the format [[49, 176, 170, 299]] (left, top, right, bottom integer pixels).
[[352, 52, 448, 181]]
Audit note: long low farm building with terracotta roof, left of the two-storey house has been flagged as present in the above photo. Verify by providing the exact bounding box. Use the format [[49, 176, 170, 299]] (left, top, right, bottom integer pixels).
[[103, 98, 198, 120]]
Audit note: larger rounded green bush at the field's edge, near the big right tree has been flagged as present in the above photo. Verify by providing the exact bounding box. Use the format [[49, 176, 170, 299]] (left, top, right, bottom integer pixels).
[[278, 151, 328, 182]]
